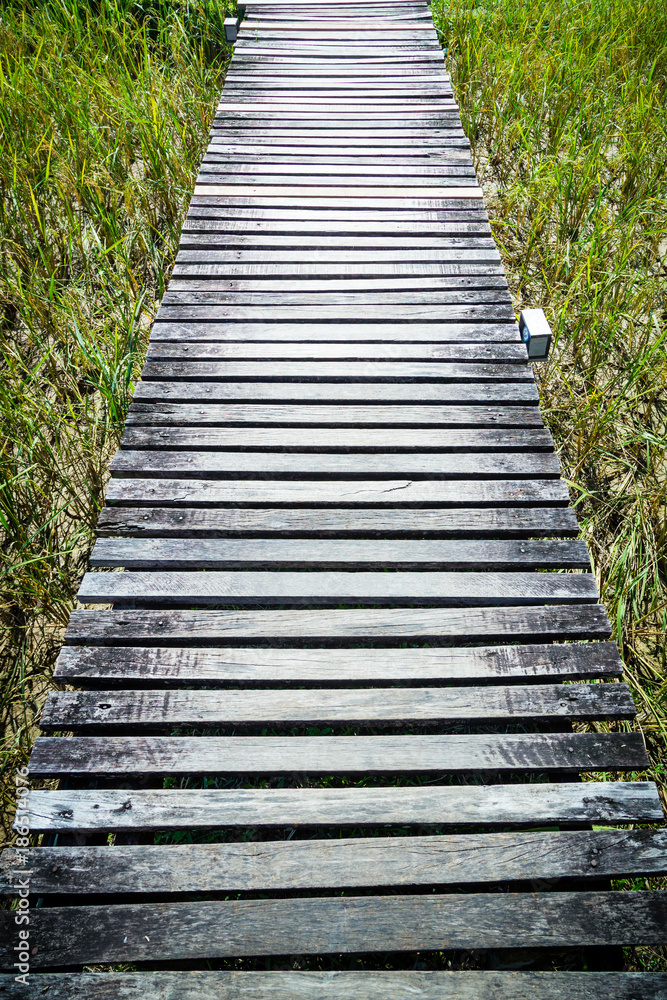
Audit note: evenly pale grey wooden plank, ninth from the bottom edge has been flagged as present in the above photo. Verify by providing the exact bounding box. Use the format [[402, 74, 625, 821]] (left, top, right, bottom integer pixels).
[[78, 569, 598, 608]]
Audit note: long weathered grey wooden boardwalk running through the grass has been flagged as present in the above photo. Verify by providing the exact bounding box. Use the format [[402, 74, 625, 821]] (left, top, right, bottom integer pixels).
[[0, 0, 667, 1000]]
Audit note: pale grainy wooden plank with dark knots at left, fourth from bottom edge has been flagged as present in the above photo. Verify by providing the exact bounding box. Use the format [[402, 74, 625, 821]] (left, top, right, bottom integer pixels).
[[22, 781, 664, 832]]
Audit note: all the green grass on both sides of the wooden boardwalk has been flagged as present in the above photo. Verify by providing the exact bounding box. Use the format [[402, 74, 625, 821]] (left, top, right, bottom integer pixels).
[[0, 0, 667, 964]]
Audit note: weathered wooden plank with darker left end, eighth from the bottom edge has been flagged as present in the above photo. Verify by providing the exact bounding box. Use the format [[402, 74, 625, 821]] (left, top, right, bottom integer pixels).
[[65, 604, 612, 644]]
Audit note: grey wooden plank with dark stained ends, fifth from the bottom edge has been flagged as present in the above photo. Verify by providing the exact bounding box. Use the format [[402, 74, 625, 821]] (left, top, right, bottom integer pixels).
[[29, 733, 649, 776]]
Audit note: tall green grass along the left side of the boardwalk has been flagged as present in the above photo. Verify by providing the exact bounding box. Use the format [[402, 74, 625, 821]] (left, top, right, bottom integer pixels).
[[0, 0, 232, 832]]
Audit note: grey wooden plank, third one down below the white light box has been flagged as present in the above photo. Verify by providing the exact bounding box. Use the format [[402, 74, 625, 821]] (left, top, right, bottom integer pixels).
[[126, 402, 543, 428]]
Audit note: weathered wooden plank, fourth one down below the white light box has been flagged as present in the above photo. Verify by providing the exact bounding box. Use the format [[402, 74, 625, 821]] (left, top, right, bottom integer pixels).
[[122, 427, 553, 455]]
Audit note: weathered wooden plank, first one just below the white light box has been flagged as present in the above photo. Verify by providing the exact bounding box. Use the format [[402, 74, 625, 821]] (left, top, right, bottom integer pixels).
[[141, 361, 533, 384]]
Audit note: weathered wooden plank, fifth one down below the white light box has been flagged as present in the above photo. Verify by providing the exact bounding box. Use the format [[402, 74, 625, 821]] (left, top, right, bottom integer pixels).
[[111, 449, 560, 480]]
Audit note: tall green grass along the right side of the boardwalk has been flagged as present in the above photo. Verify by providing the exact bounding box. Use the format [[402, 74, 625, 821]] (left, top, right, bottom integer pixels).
[[434, 0, 667, 792]]
